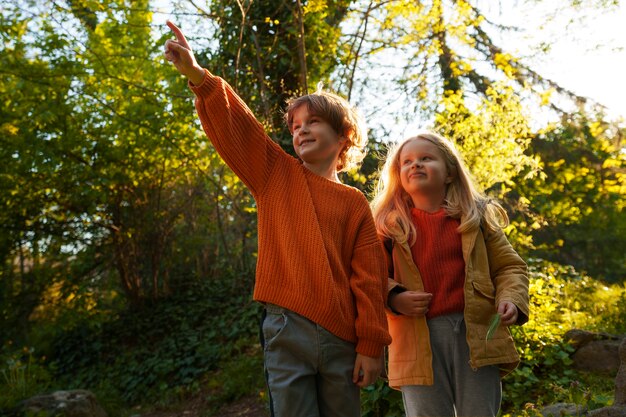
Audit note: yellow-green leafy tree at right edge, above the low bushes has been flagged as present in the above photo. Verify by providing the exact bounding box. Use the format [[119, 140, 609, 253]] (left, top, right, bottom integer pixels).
[[509, 114, 626, 282]]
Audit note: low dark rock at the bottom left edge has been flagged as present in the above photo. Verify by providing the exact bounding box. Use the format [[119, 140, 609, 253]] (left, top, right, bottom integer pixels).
[[20, 390, 108, 417]]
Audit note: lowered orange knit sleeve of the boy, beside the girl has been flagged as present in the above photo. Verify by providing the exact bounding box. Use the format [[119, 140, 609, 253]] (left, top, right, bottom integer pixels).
[[350, 203, 391, 357]]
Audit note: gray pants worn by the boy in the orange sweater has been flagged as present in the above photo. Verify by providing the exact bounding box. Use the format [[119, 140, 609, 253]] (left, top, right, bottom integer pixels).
[[261, 304, 361, 417]]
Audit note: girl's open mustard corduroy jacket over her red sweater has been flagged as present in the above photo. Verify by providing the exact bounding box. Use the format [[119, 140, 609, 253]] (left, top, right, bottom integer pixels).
[[387, 223, 529, 389]]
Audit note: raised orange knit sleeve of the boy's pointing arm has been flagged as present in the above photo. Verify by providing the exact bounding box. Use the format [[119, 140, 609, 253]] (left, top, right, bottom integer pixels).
[[189, 70, 286, 195]]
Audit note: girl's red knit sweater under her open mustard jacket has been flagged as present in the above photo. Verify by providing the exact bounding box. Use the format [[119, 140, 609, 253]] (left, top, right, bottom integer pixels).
[[411, 209, 465, 318]]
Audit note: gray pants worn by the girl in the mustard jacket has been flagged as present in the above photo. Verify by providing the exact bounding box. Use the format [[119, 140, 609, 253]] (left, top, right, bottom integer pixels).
[[401, 313, 502, 417]]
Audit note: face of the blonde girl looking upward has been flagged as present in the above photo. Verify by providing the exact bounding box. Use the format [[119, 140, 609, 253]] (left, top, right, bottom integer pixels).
[[398, 138, 452, 203]]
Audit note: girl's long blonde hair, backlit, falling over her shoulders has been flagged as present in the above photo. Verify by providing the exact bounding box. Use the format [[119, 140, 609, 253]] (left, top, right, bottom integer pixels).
[[371, 131, 509, 245]]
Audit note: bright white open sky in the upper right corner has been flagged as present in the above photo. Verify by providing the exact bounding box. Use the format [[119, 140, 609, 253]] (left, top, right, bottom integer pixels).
[[490, 0, 626, 119]]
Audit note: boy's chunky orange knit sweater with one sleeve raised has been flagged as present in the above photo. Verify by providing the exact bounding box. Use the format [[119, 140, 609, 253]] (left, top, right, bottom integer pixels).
[[190, 71, 391, 357]]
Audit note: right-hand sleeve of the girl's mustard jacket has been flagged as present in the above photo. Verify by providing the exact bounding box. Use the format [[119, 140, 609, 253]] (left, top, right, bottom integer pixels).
[[485, 229, 529, 325]]
